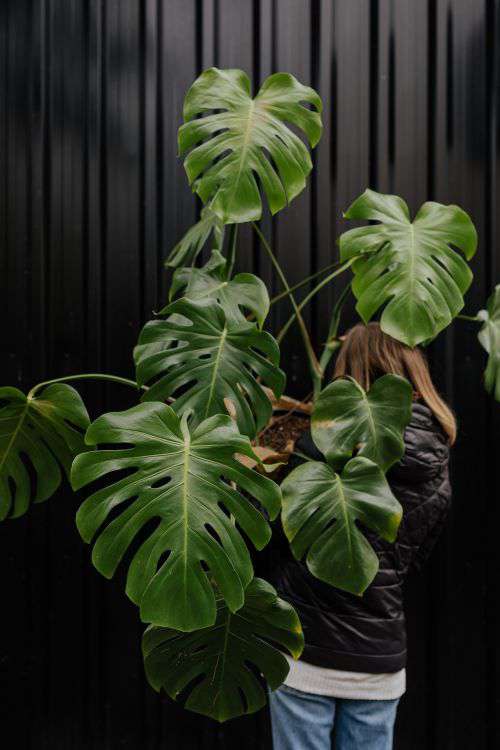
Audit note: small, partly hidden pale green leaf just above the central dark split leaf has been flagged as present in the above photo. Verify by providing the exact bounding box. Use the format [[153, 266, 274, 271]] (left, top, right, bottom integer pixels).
[[170, 250, 270, 328]]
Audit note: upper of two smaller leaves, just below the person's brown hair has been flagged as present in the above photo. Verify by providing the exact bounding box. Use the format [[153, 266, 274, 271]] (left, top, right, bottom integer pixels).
[[311, 375, 412, 472]]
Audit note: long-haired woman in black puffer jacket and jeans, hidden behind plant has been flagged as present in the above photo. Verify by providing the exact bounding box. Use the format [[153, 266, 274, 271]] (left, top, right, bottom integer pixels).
[[270, 323, 456, 750]]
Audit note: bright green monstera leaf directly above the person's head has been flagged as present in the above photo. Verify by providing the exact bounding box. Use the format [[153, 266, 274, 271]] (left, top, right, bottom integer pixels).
[[340, 190, 477, 346]]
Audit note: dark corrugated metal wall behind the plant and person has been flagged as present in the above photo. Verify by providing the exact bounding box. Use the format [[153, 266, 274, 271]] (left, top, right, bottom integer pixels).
[[0, 0, 500, 750]]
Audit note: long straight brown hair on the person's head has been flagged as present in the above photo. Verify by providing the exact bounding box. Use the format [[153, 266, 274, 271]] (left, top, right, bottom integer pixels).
[[333, 323, 457, 445]]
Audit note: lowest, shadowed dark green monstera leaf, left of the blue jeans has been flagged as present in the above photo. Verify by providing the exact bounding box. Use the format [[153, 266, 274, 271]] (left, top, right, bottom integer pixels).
[[142, 578, 304, 721]]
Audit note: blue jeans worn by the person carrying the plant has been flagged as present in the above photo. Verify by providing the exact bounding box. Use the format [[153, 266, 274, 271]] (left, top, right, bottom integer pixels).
[[269, 685, 399, 750]]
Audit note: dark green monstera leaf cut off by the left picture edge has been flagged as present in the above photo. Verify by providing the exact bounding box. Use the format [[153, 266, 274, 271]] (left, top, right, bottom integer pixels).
[[0, 383, 89, 519]]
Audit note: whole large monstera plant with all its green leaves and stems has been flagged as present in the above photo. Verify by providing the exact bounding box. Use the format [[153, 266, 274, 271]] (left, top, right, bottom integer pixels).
[[0, 68, 500, 721]]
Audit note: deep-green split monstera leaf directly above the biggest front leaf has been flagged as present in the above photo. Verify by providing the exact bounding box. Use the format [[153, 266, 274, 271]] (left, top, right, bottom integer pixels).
[[134, 298, 285, 437]]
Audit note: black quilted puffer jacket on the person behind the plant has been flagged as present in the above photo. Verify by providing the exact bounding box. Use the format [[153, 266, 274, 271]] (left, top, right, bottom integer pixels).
[[272, 404, 451, 673]]
